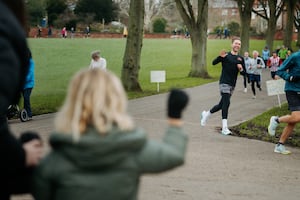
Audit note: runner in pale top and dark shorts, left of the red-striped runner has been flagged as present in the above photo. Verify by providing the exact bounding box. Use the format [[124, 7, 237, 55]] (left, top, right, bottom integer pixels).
[[248, 50, 265, 99]]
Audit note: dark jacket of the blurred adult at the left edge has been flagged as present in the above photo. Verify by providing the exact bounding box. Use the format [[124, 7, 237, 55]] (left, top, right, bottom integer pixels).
[[0, 1, 28, 200]]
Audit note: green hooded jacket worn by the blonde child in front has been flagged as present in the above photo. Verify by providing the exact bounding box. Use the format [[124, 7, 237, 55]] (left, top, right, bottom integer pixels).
[[34, 127, 187, 200]]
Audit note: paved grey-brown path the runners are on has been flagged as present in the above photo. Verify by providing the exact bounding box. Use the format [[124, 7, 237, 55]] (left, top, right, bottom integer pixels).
[[11, 70, 300, 200]]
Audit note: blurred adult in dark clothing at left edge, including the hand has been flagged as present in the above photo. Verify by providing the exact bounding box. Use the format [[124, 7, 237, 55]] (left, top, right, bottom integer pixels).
[[0, 0, 42, 200]]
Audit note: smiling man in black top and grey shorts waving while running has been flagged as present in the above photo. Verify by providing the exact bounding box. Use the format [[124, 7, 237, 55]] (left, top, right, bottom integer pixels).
[[201, 38, 246, 135]]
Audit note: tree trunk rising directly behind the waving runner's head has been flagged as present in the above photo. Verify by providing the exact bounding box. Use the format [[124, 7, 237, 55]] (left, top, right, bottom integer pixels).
[[235, 0, 254, 52]]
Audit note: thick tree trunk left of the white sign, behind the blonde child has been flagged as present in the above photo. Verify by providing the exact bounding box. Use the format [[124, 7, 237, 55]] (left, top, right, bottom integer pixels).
[[121, 0, 145, 91]]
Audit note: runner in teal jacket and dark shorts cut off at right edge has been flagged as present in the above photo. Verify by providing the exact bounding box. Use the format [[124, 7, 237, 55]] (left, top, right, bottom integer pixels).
[[268, 52, 300, 154]]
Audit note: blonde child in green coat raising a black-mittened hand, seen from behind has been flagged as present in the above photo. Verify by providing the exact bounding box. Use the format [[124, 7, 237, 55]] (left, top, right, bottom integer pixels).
[[33, 68, 189, 200]]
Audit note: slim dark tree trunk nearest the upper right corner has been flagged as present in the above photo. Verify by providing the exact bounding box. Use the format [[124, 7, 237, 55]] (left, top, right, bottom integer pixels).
[[283, 0, 296, 48]]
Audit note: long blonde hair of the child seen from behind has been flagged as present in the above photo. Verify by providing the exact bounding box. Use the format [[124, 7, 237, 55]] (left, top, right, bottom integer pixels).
[[55, 68, 133, 140]]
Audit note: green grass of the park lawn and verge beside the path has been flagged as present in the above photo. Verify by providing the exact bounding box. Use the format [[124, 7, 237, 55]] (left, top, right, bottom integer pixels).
[[28, 38, 300, 147]]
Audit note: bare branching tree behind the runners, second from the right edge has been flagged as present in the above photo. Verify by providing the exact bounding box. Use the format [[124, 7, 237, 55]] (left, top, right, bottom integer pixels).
[[252, 0, 284, 51]]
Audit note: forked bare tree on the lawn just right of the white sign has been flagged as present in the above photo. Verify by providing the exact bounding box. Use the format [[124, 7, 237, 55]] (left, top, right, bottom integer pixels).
[[175, 0, 209, 78]]
